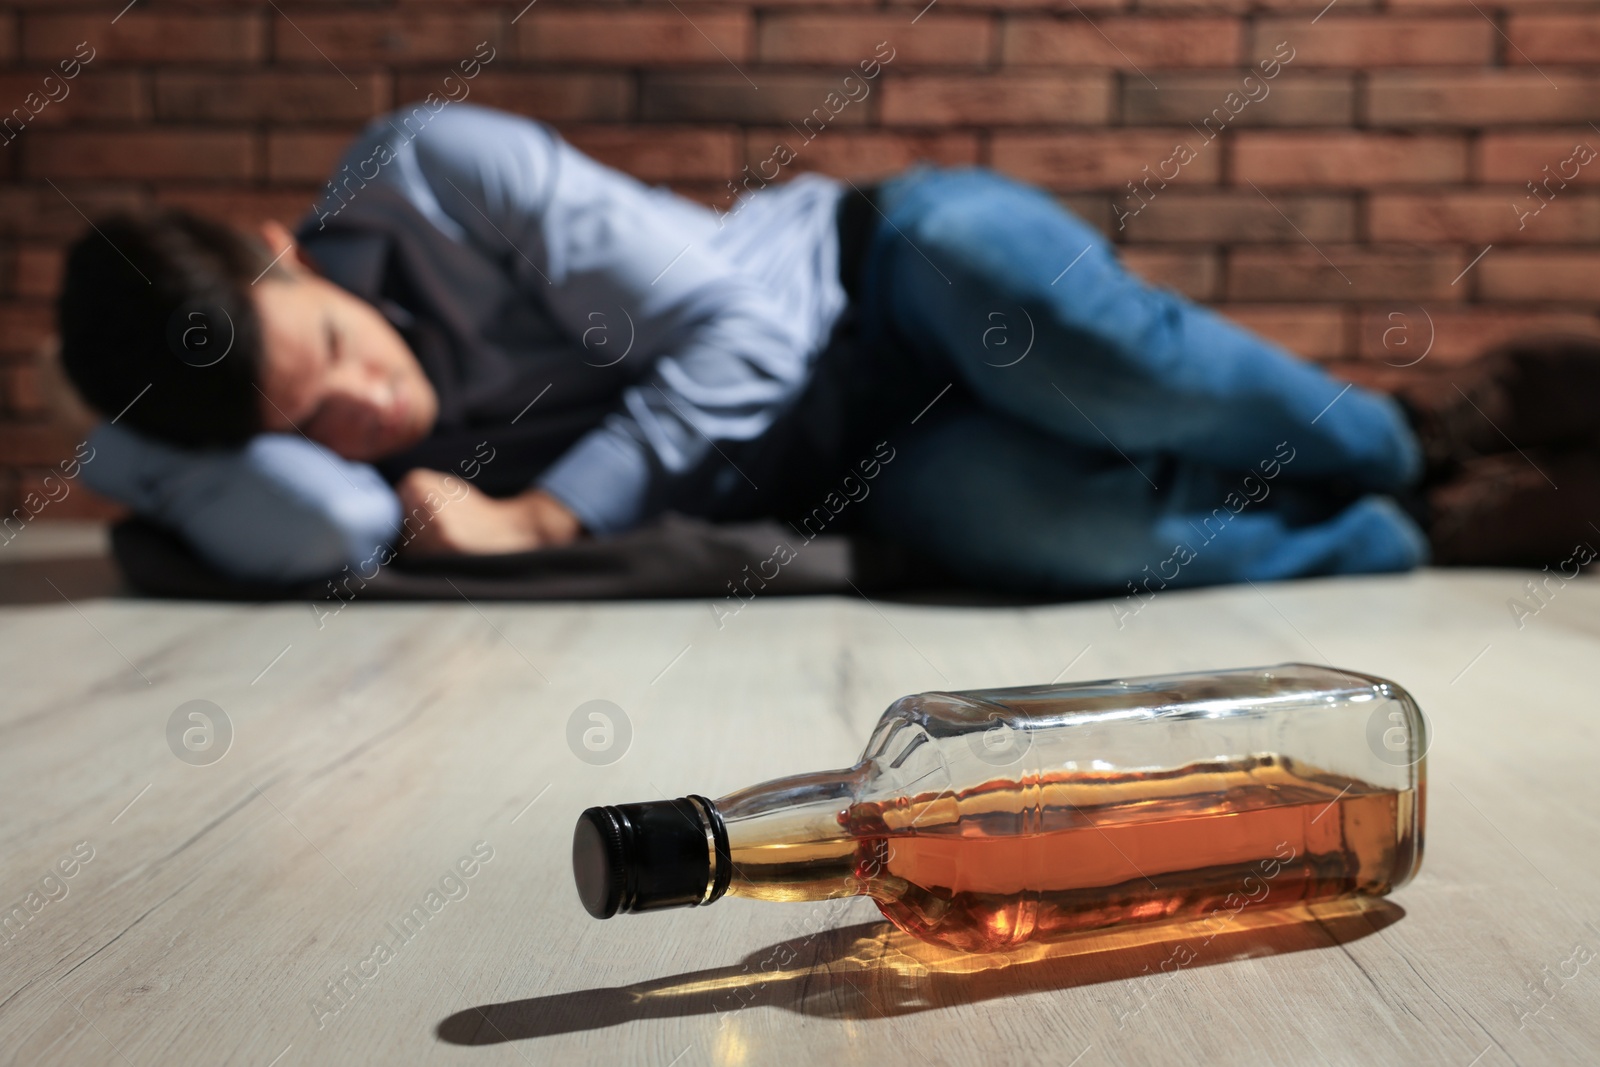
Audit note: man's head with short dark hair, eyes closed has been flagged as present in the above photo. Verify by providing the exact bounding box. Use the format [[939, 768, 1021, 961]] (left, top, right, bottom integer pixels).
[[58, 210, 438, 459]]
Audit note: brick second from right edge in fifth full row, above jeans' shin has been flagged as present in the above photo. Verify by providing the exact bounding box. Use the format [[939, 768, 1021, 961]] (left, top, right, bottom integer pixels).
[[1227, 245, 1467, 302]]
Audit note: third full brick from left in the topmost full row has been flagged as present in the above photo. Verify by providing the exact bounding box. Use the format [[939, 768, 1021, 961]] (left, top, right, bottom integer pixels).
[[517, 6, 750, 67]]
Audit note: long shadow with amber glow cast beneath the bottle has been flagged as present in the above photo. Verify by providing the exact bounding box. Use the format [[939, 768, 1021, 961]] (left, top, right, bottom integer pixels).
[[437, 897, 1405, 1045]]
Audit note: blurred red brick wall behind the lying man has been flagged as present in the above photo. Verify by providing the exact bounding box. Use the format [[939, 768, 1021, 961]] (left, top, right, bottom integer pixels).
[[0, 0, 1600, 515]]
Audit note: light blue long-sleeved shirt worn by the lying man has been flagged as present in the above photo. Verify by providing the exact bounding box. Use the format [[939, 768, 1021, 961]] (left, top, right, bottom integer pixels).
[[85, 104, 846, 581]]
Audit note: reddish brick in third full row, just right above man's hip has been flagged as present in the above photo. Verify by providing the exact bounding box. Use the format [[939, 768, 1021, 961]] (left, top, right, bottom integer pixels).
[[989, 128, 1222, 195]]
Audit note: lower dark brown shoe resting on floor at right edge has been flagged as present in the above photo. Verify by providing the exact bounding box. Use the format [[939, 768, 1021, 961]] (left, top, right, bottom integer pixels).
[[1427, 448, 1600, 568]]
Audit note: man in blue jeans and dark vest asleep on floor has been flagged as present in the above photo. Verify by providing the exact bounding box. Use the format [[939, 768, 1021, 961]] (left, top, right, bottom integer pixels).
[[59, 104, 1594, 593]]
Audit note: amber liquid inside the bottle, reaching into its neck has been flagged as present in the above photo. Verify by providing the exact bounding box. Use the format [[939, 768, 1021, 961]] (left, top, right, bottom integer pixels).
[[730, 755, 1421, 952]]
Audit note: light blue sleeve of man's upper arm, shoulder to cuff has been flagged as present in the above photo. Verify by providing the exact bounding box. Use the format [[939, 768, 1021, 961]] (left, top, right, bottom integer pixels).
[[358, 106, 813, 534]]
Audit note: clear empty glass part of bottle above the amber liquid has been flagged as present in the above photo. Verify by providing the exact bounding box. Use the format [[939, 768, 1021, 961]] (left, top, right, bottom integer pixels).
[[862, 664, 1427, 797]]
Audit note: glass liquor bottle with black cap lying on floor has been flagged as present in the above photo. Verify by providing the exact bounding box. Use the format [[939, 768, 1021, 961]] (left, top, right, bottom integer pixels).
[[573, 664, 1427, 952]]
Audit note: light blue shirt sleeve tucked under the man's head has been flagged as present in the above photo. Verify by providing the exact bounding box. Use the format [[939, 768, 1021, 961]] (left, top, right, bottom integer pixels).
[[83, 424, 400, 582]]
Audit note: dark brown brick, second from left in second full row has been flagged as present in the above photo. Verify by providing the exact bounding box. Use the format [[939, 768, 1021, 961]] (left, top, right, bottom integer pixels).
[[155, 69, 390, 122]]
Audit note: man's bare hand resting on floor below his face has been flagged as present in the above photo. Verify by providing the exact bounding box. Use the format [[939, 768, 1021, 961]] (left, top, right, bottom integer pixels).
[[395, 469, 582, 555]]
